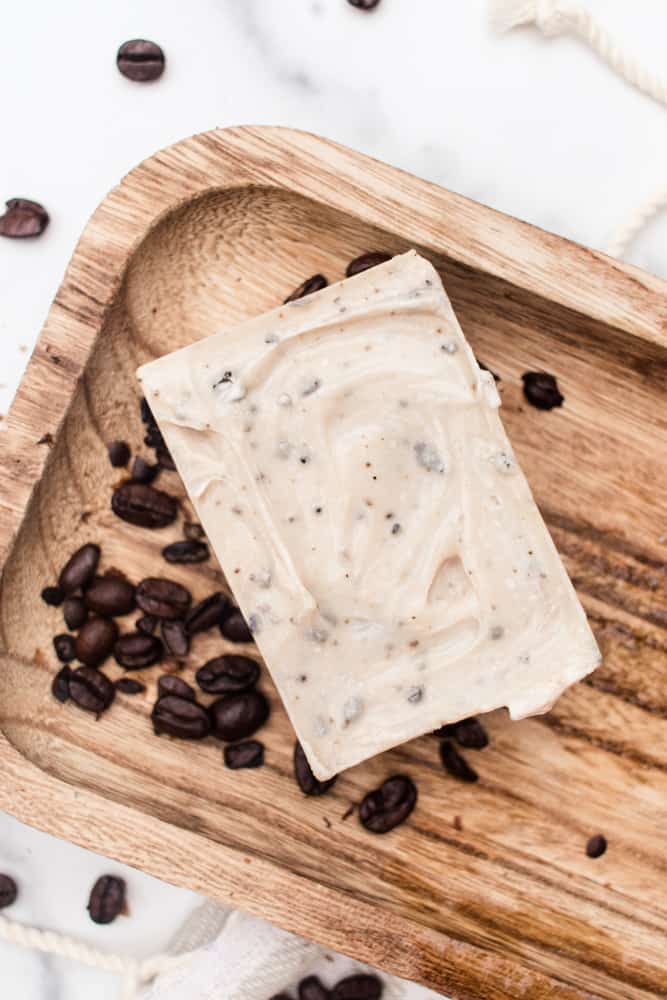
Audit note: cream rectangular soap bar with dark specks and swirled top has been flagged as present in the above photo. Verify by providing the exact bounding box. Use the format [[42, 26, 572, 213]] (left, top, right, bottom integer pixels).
[[139, 251, 600, 779]]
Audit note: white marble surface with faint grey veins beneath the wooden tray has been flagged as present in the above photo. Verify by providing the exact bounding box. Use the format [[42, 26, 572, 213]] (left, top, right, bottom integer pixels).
[[0, 0, 667, 1000]]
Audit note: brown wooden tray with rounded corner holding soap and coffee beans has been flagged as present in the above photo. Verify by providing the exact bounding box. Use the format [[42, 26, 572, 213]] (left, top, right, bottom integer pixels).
[[0, 128, 667, 1000]]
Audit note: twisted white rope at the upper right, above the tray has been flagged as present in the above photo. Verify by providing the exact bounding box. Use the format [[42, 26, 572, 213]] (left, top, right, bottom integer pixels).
[[491, 0, 667, 257]]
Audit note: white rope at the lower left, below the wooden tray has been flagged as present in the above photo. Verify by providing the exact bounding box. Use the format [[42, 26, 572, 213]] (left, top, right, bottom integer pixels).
[[0, 916, 190, 1000]]
